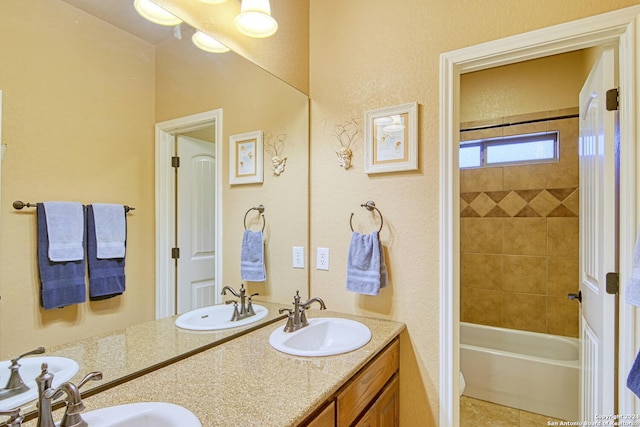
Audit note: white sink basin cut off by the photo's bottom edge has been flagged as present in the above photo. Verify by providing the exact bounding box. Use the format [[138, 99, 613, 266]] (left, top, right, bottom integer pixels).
[[82, 402, 202, 427]]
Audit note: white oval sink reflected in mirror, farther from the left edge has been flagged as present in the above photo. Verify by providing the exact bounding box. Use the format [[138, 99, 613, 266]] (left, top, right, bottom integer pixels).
[[176, 304, 269, 331]]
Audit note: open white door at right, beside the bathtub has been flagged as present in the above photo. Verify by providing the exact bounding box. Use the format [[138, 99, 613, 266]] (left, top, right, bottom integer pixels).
[[580, 48, 618, 421]]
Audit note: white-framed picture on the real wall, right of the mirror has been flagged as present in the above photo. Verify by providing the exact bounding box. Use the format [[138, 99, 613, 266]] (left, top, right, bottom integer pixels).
[[364, 102, 418, 174]]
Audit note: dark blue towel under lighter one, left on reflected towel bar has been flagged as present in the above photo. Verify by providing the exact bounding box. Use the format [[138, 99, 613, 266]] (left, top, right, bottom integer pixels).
[[36, 203, 87, 310]]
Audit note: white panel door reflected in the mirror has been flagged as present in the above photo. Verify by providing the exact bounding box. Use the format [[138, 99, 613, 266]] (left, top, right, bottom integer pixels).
[[176, 135, 216, 314]]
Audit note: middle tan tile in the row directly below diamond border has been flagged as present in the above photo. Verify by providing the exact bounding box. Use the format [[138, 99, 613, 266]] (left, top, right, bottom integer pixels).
[[503, 218, 547, 256]]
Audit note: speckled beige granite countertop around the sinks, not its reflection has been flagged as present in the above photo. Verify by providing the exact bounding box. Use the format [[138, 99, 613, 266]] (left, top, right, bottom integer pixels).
[[23, 310, 405, 427]]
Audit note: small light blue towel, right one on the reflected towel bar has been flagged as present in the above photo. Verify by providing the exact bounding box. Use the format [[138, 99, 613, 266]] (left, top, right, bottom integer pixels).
[[91, 203, 127, 259]]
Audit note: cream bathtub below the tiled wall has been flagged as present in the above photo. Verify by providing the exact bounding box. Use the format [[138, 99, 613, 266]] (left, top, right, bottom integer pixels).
[[460, 322, 580, 421]]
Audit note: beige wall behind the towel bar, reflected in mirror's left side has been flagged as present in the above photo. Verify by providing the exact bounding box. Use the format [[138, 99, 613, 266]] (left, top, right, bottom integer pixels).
[[0, 0, 155, 360]]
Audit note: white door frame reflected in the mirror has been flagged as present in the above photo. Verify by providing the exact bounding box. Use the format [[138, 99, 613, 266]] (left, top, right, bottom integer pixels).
[[155, 108, 223, 319]]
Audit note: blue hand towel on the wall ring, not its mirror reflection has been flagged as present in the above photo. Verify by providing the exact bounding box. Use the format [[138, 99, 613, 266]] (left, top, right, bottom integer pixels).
[[347, 231, 387, 295]]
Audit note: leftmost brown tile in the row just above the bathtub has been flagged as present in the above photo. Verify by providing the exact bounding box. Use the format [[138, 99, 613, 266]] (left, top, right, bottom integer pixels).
[[460, 288, 503, 326]]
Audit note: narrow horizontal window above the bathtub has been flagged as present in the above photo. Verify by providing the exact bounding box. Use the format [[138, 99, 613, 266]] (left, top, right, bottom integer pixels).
[[460, 131, 560, 169]]
